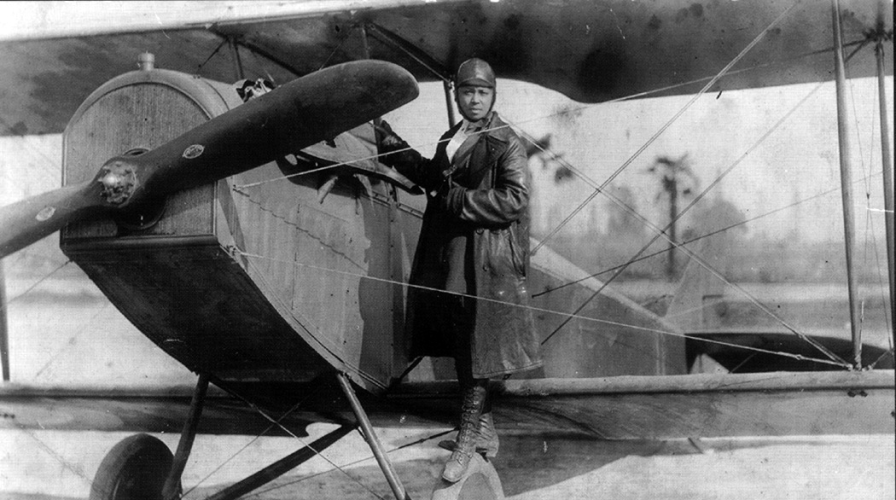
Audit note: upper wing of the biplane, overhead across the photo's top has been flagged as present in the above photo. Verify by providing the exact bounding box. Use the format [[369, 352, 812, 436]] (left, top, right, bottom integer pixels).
[[0, 0, 893, 135]]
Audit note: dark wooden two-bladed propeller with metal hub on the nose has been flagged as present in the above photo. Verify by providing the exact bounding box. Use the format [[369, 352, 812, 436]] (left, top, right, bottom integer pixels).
[[0, 60, 418, 258]]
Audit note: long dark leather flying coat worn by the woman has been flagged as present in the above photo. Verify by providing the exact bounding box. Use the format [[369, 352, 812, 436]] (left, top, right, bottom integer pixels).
[[383, 112, 542, 378]]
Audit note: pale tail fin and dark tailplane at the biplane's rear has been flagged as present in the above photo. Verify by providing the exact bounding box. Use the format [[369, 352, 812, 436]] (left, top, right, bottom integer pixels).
[[663, 238, 894, 373]]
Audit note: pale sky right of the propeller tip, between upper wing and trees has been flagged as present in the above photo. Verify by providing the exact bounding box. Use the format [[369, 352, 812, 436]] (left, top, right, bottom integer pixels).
[[386, 77, 893, 241]]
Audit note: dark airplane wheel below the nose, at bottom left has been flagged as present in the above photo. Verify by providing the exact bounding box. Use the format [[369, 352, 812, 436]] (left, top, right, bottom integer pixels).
[[90, 434, 174, 500]]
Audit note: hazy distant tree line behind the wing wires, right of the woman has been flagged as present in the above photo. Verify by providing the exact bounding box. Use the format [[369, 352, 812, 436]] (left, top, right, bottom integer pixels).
[[533, 149, 885, 283]]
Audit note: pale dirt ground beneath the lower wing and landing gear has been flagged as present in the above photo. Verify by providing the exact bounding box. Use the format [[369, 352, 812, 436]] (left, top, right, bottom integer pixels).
[[0, 425, 896, 500]]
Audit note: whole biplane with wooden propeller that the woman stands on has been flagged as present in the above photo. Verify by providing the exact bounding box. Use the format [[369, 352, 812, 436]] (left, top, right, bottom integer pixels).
[[0, 0, 894, 500]]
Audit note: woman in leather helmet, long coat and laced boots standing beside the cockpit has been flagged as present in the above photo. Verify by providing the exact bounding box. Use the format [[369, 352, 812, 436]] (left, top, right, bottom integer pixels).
[[380, 59, 542, 482]]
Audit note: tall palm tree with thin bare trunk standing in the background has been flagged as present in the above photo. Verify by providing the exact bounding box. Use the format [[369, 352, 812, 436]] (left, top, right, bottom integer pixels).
[[647, 153, 700, 281]]
